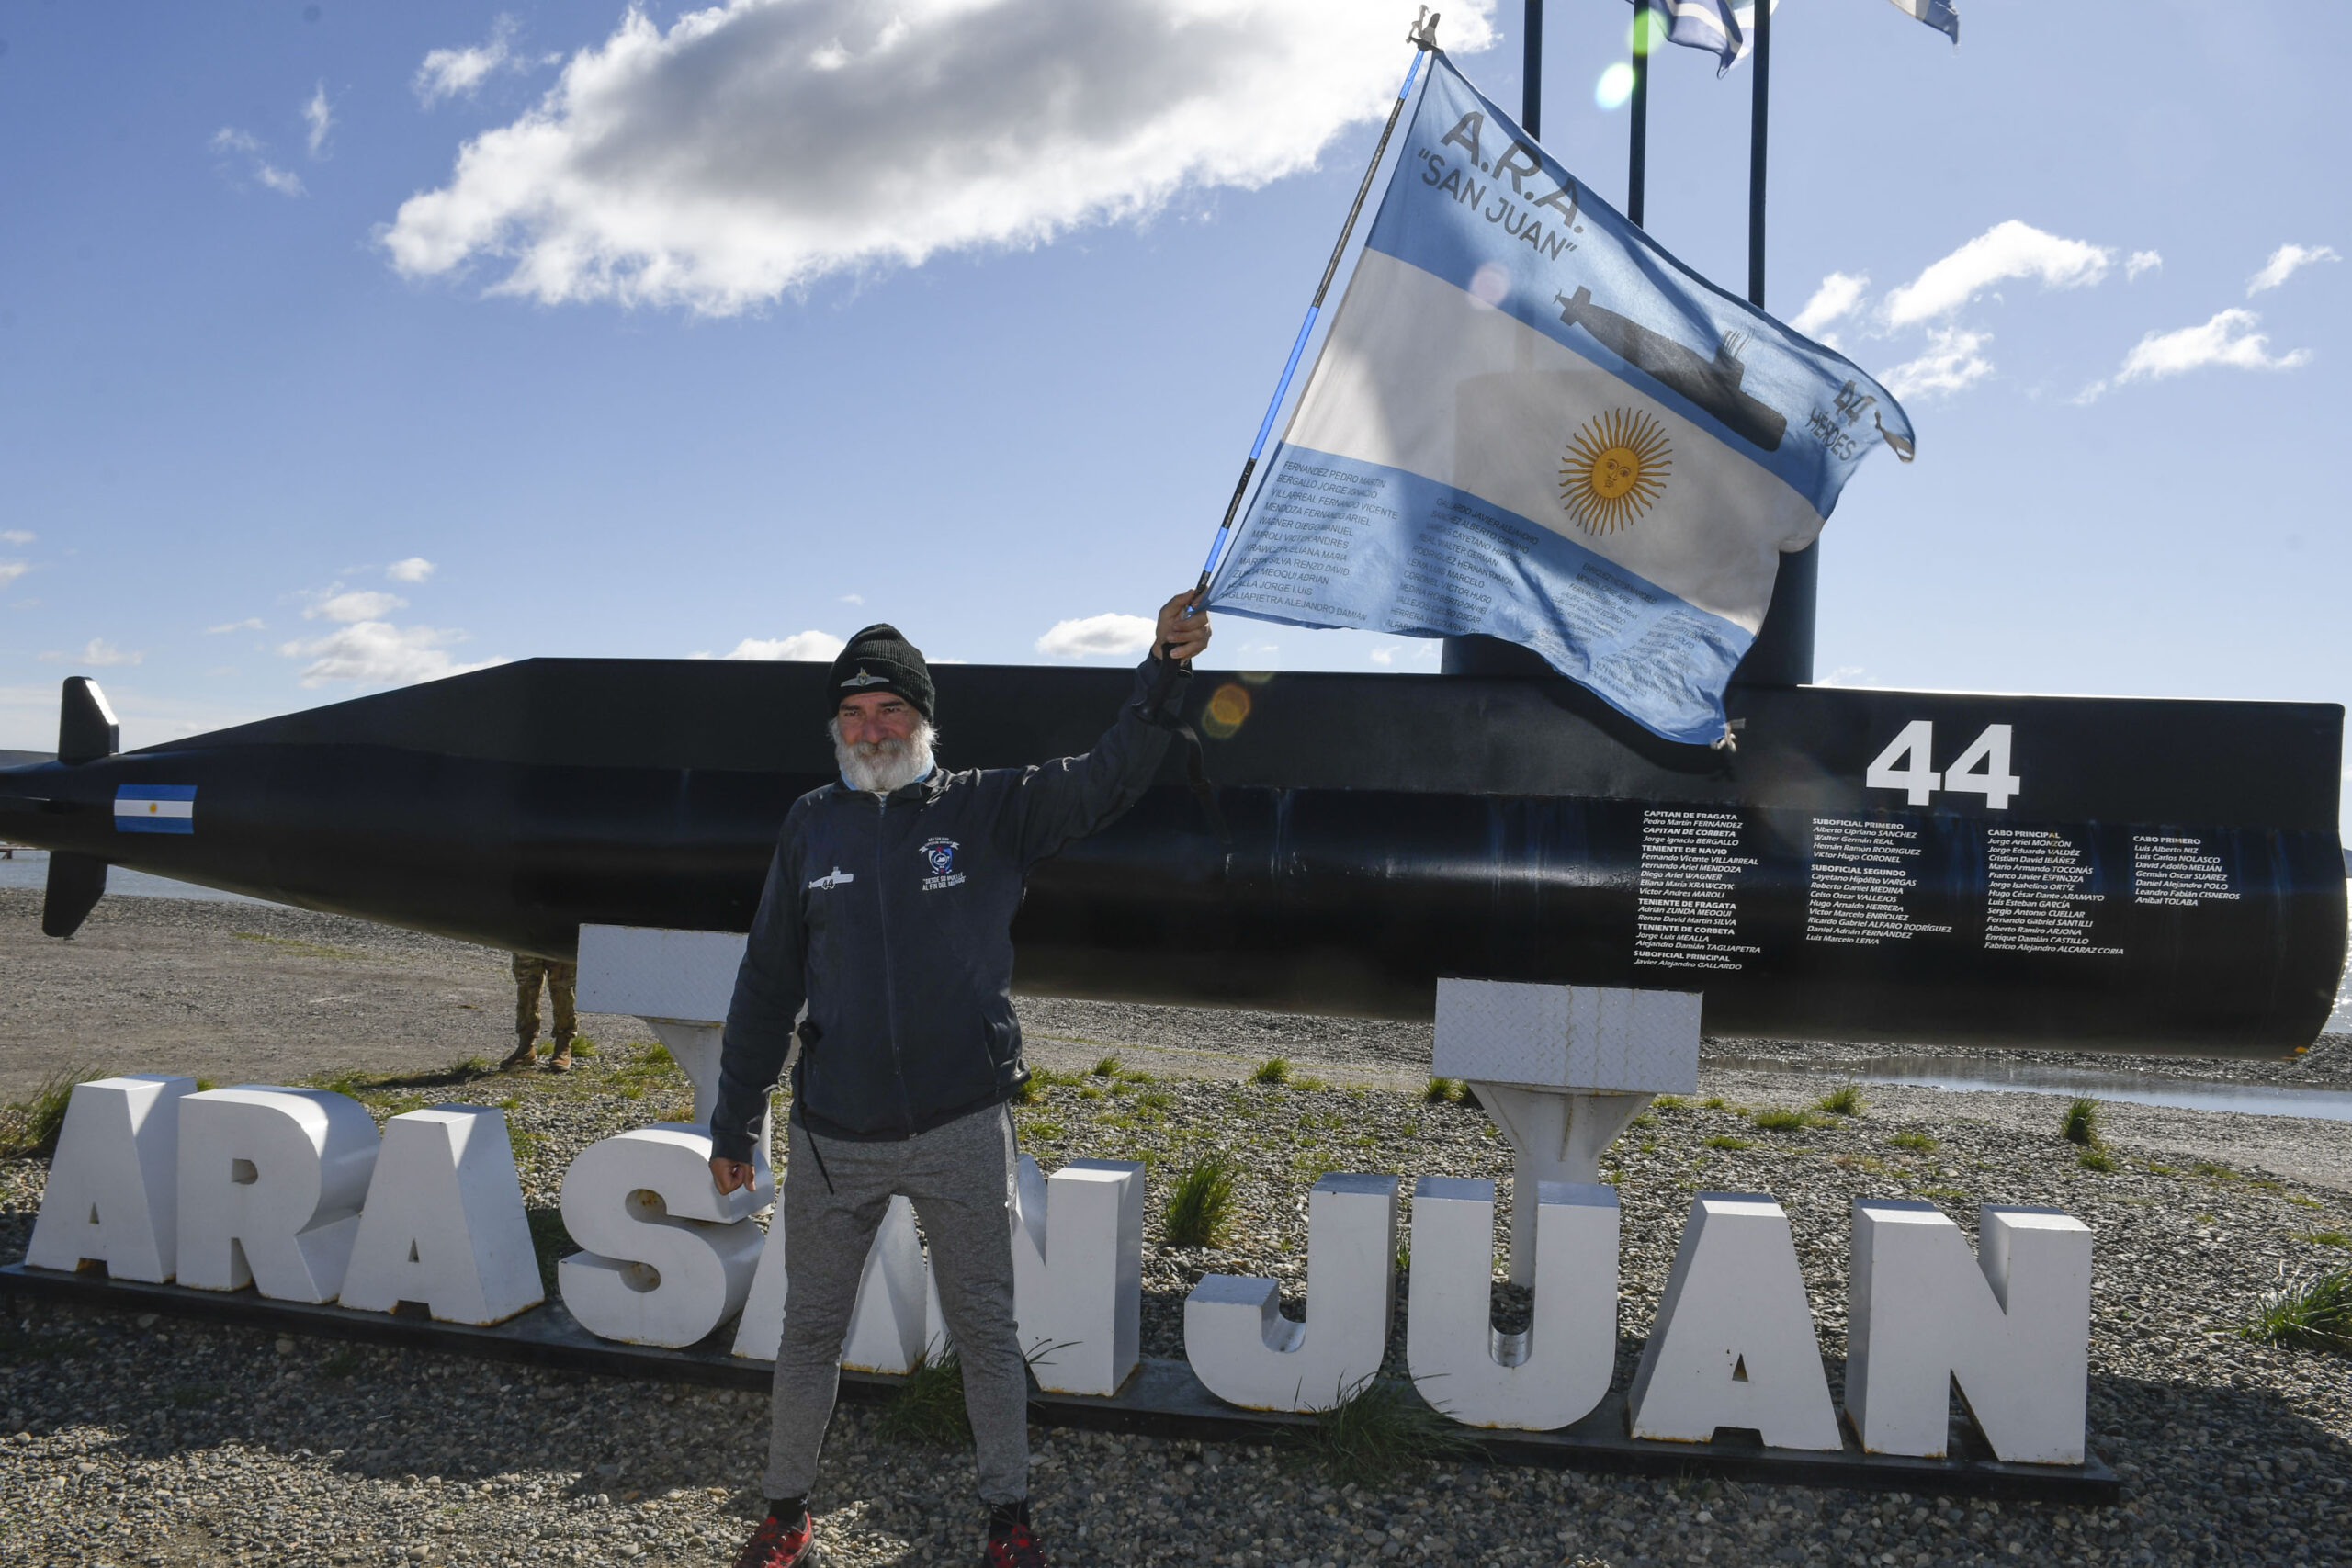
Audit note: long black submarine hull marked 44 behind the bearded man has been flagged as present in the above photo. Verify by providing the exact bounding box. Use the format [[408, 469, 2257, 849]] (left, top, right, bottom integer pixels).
[[0, 659, 2345, 1055]]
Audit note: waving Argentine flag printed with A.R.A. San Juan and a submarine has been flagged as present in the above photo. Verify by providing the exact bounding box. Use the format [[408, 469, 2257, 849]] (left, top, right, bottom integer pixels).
[[1209, 54, 1912, 743]]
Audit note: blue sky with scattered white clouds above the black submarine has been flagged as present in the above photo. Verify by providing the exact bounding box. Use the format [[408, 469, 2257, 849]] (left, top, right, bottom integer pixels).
[[0, 0, 2352, 822]]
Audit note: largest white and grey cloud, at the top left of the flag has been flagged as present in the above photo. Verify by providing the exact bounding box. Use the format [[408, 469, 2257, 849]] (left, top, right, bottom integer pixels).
[[379, 0, 1494, 315]]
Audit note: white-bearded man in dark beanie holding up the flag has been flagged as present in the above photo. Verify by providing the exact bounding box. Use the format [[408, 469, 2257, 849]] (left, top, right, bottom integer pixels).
[[710, 592, 1209, 1568]]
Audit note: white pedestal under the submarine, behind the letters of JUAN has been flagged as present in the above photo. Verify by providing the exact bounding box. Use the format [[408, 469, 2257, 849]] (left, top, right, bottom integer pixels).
[[1430, 980, 1701, 1286]]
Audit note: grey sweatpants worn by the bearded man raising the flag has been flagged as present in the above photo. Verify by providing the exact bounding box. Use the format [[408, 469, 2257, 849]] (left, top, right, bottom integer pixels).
[[764, 1105, 1028, 1502]]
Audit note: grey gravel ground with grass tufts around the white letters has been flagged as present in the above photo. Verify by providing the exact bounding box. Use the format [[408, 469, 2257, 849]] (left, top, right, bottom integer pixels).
[[0, 896, 2352, 1568]]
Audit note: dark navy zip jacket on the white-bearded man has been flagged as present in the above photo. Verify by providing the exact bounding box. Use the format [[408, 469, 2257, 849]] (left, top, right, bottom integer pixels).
[[710, 659, 1188, 1159]]
